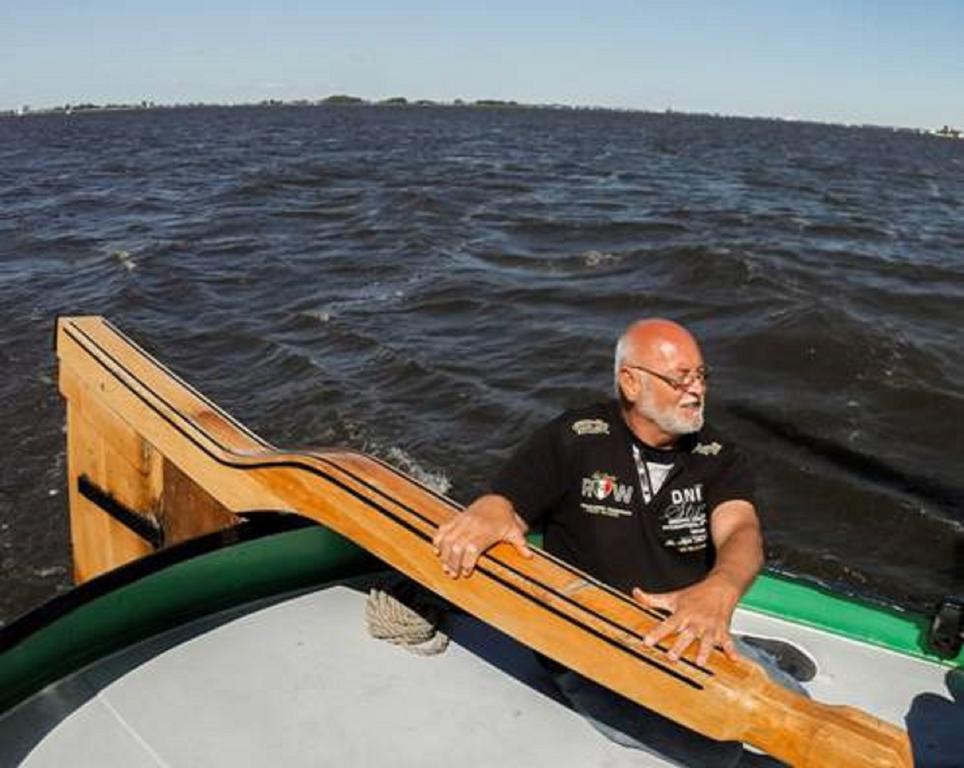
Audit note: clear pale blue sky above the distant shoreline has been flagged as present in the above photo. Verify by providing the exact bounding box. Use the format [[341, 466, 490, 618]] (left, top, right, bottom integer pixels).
[[0, 0, 964, 128]]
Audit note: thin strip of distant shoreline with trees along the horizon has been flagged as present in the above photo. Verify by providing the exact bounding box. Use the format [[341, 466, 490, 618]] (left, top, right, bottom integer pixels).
[[0, 94, 964, 139]]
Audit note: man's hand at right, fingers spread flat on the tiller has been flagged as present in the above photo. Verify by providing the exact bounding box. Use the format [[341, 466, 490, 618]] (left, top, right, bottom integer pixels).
[[633, 573, 740, 666]]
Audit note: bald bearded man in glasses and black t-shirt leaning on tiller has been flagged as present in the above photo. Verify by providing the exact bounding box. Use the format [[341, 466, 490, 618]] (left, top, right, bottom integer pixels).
[[434, 319, 792, 765]]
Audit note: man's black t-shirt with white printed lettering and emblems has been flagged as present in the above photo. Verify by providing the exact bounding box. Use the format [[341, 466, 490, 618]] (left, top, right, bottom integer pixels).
[[491, 401, 753, 592]]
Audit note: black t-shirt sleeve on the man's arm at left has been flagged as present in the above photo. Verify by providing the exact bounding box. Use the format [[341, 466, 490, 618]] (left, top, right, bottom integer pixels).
[[490, 421, 565, 525]]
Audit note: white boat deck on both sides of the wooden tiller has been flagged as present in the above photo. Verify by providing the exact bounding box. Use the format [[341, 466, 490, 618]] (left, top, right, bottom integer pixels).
[[0, 586, 964, 768]]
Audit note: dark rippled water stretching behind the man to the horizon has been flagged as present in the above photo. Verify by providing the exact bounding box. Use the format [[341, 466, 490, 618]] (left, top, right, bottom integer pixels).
[[0, 107, 964, 620]]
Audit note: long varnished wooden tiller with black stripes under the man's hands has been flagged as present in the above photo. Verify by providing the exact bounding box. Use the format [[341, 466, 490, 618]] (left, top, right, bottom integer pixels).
[[57, 318, 912, 768]]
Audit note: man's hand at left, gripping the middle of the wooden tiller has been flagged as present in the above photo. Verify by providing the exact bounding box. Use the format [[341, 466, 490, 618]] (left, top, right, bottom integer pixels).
[[432, 494, 532, 579]]
